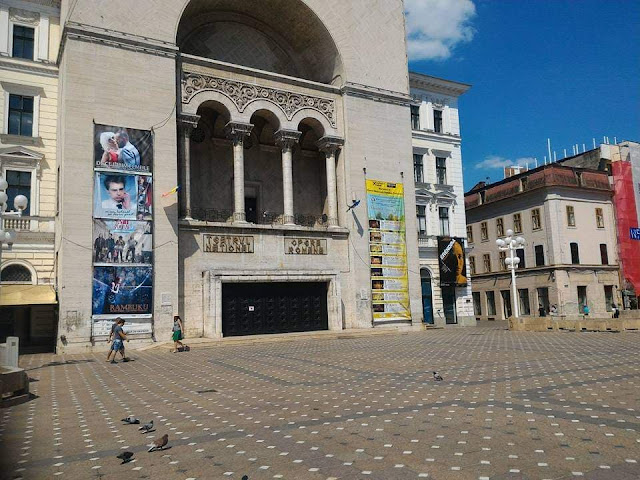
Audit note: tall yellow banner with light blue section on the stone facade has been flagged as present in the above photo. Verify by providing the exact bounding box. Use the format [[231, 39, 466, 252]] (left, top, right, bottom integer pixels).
[[367, 180, 411, 322]]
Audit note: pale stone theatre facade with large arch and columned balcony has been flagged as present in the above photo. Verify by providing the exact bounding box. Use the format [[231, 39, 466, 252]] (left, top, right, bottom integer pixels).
[[56, 0, 452, 351]]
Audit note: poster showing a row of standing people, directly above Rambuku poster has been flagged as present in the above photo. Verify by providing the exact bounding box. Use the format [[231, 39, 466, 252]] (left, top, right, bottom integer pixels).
[[93, 218, 153, 265]]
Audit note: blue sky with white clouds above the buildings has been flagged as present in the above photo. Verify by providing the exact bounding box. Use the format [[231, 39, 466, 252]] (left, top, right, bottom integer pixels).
[[405, 0, 640, 190]]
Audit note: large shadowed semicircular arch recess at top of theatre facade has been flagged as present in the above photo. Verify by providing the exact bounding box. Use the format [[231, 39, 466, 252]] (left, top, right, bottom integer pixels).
[[176, 0, 343, 85]]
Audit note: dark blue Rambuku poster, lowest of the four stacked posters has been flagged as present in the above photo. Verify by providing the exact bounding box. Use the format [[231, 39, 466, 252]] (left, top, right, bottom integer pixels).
[[92, 265, 153, 317]]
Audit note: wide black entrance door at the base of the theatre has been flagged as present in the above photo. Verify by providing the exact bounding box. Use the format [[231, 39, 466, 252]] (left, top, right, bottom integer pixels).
[[222, 282, 329, 337]]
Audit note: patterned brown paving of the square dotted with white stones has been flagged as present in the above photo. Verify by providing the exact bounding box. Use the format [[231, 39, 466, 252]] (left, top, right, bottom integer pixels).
[[0, 324, 640, 480]]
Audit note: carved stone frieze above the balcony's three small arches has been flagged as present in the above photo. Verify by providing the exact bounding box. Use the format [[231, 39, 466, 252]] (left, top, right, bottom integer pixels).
[[182, 73, 336, 127]]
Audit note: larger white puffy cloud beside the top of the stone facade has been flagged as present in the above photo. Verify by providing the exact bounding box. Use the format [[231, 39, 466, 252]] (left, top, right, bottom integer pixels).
[[405, 0, 476, 60]]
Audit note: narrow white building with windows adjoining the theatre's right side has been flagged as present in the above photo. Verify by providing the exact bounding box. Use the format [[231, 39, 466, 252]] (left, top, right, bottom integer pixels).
[[409, 72, 475, 325]]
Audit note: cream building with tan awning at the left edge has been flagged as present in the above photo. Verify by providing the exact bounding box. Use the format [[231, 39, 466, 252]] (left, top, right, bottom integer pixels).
[[0, 0, 60, 351]]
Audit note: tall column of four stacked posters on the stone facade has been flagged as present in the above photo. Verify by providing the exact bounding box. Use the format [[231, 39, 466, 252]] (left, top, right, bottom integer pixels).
[[91, 124, 154, 336]]
